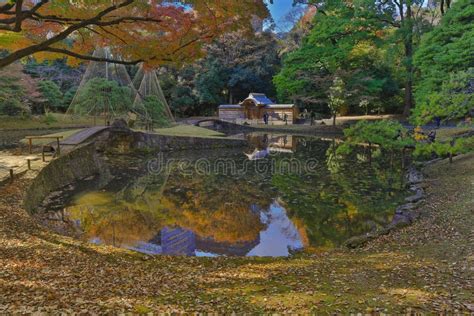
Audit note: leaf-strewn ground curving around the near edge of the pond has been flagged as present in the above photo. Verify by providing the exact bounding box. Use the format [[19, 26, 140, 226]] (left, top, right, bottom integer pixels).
[[0, 155, 474, 314]]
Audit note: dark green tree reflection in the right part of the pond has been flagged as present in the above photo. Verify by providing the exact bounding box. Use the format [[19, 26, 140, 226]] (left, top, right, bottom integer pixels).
[[272, 141, 403, 248]]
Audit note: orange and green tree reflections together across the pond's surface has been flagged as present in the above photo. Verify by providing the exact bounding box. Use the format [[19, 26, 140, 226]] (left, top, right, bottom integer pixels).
[[68, 140, 403, 252]]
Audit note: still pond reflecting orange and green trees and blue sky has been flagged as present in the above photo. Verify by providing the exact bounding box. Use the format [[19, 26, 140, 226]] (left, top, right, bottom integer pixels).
[[42, 134, 406, 256]]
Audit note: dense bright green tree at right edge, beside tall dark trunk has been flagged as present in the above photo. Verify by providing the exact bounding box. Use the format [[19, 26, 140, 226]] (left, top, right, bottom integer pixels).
[[414, 0, 474, 123]]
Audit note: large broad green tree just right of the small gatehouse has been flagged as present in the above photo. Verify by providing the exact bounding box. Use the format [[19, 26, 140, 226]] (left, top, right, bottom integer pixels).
[[274, 0, 398, 112]]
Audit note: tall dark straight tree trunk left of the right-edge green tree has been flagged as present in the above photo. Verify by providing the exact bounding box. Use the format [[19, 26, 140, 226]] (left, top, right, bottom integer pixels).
[[402, 0, 413, 117]]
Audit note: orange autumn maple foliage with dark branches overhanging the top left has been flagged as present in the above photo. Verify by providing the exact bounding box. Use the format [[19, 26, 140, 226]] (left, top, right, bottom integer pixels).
[[0, 0, 268, 67]]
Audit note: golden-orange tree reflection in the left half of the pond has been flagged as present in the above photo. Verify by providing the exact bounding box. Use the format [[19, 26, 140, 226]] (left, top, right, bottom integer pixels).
[[67, 158, 271, 246]]
